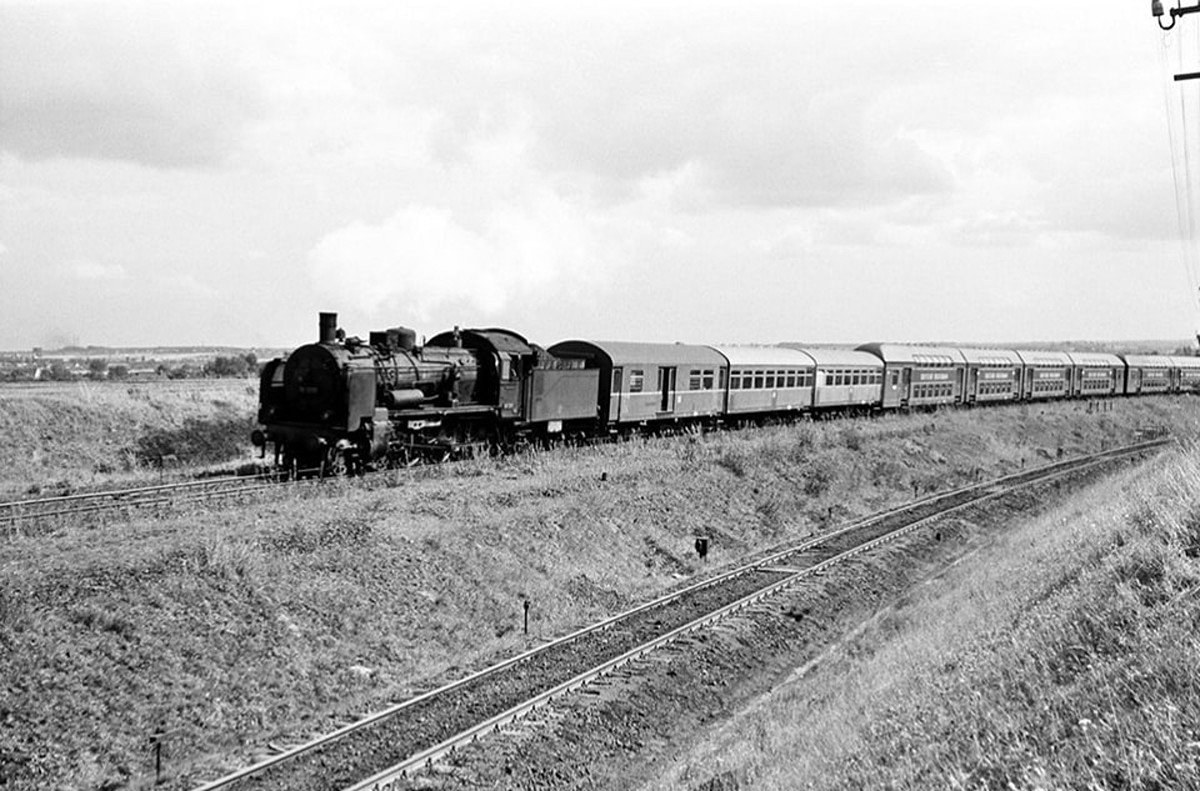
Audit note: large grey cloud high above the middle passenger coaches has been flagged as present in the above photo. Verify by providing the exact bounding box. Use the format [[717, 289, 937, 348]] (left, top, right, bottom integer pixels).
[[501, 7, 953, 210]]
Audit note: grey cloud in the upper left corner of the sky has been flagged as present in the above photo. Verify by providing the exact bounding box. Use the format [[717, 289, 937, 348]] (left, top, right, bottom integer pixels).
[[0, 4, 258, 167]]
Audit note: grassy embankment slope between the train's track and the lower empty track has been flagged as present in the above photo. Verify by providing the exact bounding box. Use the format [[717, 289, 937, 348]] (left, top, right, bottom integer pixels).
[[0, 399, 1195, 787]]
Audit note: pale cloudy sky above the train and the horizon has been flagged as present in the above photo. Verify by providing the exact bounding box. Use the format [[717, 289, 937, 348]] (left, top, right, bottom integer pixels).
[[0, 0, 1200, 349]]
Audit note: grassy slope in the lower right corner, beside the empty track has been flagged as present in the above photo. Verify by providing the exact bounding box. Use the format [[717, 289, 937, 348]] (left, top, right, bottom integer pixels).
[[655, 444, 1200, 789]]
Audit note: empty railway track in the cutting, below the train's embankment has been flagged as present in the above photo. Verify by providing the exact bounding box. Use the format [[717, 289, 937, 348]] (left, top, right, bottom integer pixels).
[[187, 439, 1170, 791]]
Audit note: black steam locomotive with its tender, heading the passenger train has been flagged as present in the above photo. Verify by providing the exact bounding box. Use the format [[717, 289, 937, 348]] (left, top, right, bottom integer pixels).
[[251, 313, 595, 473]]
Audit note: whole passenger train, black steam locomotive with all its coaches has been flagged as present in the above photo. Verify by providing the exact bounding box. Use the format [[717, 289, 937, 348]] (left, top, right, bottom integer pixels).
[[251, 313, 1200, 474]]
